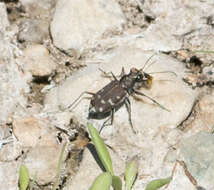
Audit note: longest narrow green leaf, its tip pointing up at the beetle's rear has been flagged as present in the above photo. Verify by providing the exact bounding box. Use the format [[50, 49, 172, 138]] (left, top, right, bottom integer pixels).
[[88, 123, 114, 176]]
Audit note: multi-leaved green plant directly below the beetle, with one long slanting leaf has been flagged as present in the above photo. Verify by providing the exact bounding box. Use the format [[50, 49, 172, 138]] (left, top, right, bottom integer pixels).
[[88, 123, 172, 190]]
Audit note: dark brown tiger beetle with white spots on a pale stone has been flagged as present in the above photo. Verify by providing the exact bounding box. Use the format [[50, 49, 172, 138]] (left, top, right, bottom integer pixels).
[[68, 57, 174, 134]]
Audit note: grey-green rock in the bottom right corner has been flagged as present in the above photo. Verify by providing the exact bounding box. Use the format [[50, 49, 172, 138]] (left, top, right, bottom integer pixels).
[[180, 132, 214, 190]]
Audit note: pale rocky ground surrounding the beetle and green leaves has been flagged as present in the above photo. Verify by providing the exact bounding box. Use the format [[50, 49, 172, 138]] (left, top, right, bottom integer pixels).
[[0, 0, 214, 190]]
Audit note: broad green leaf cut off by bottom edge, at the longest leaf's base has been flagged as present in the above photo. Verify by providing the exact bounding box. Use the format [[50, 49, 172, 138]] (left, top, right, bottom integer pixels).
[[89, 172, 112, 190]]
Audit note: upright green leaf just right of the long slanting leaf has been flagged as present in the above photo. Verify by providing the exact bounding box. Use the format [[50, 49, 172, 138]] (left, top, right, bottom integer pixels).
[[125, 160, 138, 190]]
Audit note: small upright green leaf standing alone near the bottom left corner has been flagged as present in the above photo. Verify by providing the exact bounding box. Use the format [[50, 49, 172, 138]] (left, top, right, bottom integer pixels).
[[19, 165, 30, 190]]
